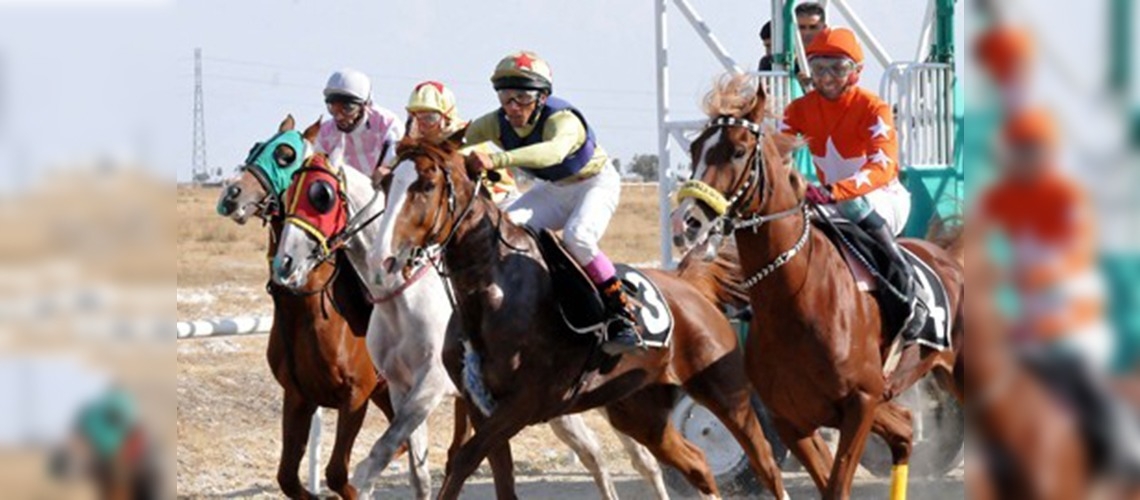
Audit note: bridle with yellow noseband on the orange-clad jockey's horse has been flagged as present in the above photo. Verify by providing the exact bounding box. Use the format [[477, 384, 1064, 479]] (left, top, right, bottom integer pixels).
[[677, 112, 812, 288]]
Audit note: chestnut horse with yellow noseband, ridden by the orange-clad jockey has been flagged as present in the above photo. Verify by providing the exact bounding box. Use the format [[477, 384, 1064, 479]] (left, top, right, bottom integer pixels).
[[671, 75, 964, 500]]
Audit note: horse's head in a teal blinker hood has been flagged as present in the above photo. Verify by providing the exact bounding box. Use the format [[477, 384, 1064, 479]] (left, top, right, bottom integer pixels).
[[217, 115, 320, 224]]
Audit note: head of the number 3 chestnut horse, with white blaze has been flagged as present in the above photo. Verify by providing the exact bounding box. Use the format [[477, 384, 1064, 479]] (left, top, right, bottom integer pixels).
[[368, 134, 479, 287]]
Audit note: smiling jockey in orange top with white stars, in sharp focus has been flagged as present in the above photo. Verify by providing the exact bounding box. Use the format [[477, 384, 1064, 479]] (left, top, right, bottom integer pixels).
[[780, 27, 933, 343]]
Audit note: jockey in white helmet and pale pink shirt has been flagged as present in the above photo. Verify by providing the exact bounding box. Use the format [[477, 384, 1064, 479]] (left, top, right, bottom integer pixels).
[[315, 69, 404, 182]]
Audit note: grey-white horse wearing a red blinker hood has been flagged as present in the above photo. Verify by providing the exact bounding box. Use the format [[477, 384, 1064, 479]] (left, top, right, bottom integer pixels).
[[267, 142, 668, 499]]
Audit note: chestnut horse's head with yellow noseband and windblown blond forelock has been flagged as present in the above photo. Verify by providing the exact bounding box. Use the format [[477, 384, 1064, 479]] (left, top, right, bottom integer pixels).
[[671, 75, 804, 249]]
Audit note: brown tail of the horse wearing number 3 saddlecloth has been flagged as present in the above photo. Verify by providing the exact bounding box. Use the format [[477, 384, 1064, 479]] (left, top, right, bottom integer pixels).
[[677, 239, 748, 310]]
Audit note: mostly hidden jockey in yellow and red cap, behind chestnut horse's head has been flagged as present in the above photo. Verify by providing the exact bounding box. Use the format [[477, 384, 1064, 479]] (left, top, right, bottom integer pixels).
[[405, 81, 519, 207]]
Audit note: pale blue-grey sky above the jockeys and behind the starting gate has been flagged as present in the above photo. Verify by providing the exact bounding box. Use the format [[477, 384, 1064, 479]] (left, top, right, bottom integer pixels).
[[0, 0, 971, 182]]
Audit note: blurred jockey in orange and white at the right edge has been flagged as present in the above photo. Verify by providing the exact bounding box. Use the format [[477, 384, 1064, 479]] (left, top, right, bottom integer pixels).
[[979, 108, 1140, 477]]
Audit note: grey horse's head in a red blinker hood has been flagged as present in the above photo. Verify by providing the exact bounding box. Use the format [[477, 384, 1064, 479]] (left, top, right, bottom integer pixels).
[[272, 154, 351, 290]]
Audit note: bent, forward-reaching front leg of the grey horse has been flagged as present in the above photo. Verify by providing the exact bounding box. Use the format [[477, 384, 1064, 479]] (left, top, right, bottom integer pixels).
[[352, 366, 447, 494]]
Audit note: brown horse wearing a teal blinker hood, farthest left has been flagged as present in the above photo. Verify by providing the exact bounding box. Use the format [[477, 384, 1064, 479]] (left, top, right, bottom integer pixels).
[[217, 116, 393, 499]]
